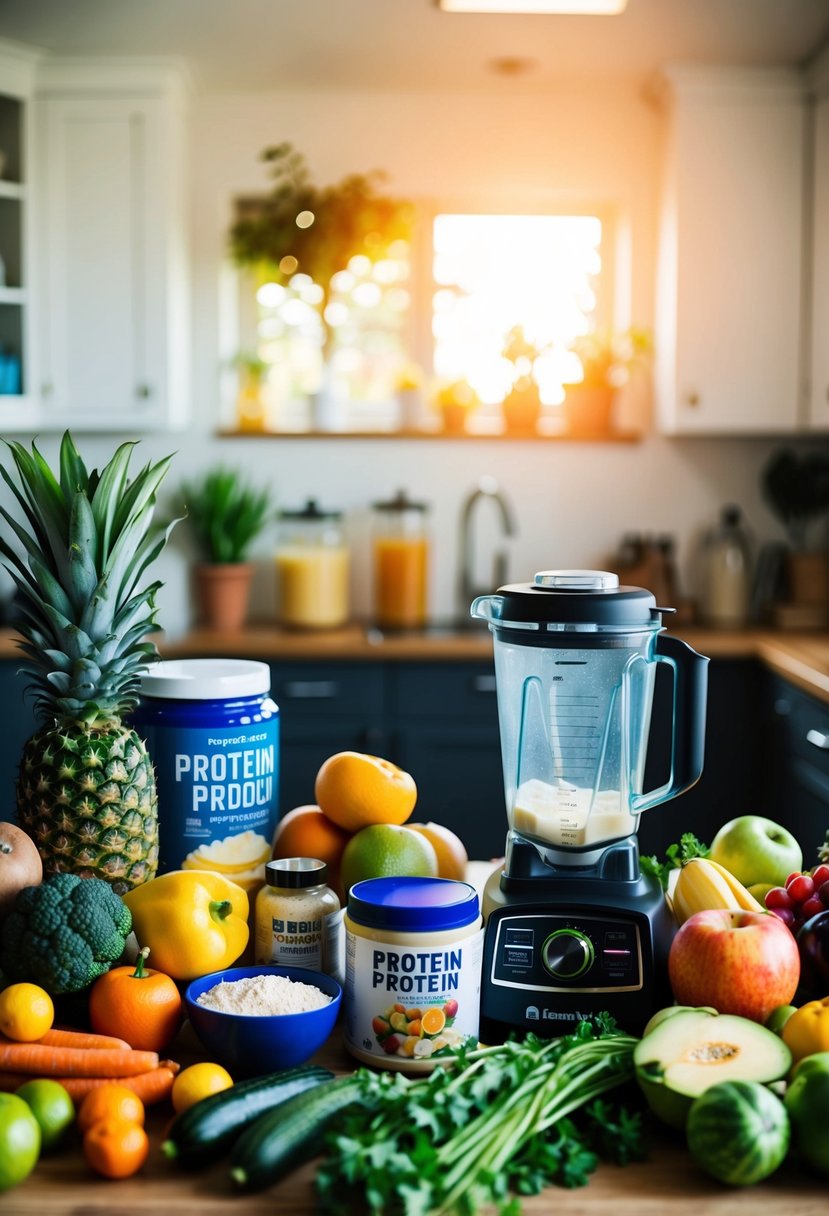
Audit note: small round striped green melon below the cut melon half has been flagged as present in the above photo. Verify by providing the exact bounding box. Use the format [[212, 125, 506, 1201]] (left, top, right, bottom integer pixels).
[[686, 1081, 790, 1187]]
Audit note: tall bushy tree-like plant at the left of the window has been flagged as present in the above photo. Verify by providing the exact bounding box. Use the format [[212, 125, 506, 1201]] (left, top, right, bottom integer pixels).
[[230, 142, 415, 413]]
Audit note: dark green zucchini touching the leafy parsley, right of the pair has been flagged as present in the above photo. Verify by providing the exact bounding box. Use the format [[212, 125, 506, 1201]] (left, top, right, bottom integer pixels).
[[230, 1075, 362, 1190]]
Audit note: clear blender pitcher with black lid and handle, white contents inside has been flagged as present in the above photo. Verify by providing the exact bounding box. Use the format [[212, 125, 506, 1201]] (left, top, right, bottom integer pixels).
[[472, 570, 707, 860]]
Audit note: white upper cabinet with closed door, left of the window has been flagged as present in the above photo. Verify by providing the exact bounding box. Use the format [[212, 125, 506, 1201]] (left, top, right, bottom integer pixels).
[[30, 61, 190, 432]]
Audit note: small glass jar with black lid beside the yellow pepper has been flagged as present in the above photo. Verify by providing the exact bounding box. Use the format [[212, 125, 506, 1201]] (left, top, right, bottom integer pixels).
[[254, 857, 343, 975]]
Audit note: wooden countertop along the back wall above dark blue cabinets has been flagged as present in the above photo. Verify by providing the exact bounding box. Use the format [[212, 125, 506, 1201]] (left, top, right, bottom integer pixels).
[[0, 624, 829, 703]]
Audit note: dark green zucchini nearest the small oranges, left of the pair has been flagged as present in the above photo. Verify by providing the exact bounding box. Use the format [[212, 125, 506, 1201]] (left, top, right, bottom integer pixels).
[[162, 1064, 334, 1166]]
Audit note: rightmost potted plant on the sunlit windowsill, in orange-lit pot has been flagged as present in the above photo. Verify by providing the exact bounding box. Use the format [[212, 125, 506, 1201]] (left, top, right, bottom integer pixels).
[[564, 326, 653, 438]]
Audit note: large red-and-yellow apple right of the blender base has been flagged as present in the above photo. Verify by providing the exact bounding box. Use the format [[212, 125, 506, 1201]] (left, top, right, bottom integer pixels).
[[667, 908, 800, 1023]]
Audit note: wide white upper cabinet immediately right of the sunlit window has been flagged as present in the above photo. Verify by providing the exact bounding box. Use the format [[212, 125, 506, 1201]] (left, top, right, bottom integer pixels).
[[655, 67, 807, 435]]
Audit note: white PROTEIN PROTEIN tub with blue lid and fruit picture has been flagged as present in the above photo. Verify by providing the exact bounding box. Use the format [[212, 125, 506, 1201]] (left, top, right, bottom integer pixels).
[[344, 878, 483, 1073]]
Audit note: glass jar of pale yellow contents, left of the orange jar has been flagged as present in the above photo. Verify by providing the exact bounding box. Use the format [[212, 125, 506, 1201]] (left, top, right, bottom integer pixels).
[[275, 499, 349, 629]]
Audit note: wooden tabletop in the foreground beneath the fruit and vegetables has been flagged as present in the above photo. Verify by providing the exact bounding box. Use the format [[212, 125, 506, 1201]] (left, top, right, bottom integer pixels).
[[0, 1026, 827, 1216]]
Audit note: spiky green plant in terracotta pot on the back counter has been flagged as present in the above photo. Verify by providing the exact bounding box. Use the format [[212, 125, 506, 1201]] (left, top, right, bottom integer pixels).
[[182, 466, 272, 630]]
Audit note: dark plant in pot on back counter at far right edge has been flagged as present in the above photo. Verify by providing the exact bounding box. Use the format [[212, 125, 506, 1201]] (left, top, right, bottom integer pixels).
[[761, 449, 829, 609]]
